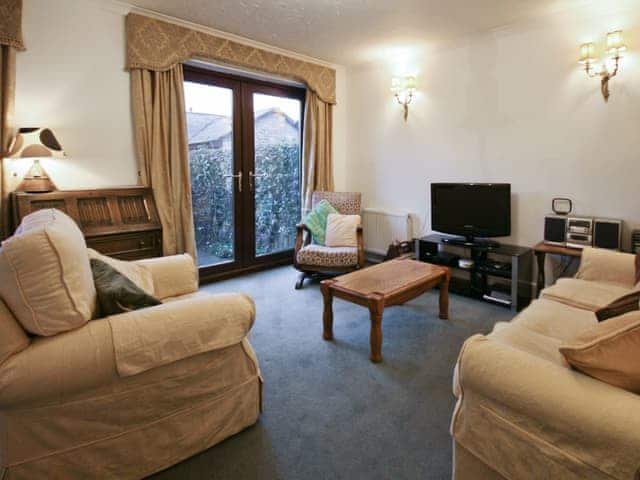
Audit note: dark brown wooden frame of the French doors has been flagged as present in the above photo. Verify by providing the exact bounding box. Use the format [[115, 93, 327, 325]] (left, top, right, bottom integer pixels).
[[183, 65, 306, 282]]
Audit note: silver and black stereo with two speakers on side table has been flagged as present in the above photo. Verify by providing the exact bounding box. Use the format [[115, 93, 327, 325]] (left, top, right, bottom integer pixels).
[[544, 215, 622, 250]]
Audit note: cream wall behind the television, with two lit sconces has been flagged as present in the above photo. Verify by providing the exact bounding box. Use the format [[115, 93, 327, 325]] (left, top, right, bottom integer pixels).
[[347, 2, 640, 251]]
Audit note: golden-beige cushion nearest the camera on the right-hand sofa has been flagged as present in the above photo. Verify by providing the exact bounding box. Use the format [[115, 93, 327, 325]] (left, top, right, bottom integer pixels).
[[560, 312, 640, 393]]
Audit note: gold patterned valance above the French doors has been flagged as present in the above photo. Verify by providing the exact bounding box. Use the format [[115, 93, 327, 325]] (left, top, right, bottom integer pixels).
[[126, 13, 336, 104]]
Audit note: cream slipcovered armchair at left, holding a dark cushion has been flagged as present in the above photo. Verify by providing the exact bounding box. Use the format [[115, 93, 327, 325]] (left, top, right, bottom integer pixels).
[[0, 210, 261, 480]]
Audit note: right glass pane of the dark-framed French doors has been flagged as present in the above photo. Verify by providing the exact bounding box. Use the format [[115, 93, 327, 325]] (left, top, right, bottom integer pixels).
[[249, 93, 302, 257]]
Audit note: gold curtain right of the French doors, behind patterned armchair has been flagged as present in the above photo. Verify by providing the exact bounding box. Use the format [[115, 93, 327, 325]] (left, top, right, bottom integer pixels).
[[302, 90, 334, 212]]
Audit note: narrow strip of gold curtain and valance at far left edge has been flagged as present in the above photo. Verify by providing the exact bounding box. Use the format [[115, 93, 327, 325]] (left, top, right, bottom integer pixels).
[[0, 0, 24, 240]]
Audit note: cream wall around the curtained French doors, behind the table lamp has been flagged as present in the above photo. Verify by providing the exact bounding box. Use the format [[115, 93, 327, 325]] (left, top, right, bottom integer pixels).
[[12, 0, 346, 189]]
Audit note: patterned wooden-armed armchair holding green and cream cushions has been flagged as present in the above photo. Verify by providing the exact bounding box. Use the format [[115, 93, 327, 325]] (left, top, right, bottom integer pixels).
[[294, 191, 365, 290]]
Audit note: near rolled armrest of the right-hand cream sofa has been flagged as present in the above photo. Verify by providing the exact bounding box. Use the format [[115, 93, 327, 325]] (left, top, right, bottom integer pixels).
[[452, 335, 640, 478]]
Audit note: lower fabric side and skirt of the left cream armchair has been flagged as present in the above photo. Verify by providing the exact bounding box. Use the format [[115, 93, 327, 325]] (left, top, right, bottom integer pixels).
[[0, 340, 262, 480]]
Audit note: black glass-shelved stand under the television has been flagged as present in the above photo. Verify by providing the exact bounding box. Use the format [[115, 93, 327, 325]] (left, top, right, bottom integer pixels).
[[416, 234, 533, 311]]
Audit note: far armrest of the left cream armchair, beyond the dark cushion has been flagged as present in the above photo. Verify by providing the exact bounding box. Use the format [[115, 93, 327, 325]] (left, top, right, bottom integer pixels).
[[135, 253, 198, 300]]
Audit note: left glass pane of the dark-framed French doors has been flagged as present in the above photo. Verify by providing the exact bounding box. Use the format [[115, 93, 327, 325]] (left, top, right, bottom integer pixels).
[[184, 81, 242, 267]]
